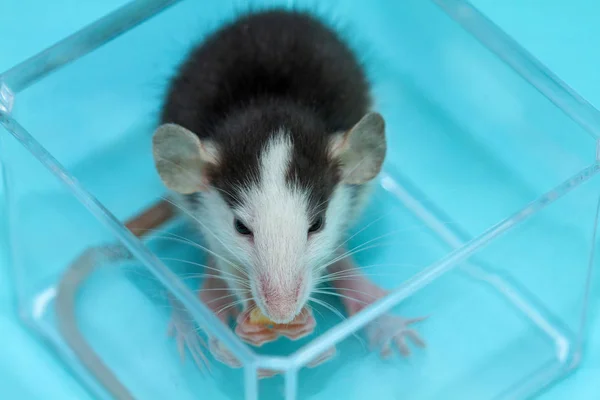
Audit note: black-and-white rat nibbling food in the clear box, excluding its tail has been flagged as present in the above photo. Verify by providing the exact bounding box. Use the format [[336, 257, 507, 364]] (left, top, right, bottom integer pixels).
[[152, 9, 424, 366]]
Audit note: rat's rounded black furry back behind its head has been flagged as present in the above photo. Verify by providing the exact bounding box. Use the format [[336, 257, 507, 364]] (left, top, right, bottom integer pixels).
[[162, 10, 370, 141]]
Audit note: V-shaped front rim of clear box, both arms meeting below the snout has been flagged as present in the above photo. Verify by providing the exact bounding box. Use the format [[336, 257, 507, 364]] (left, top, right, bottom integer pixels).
[[0, 111, 600, 371]]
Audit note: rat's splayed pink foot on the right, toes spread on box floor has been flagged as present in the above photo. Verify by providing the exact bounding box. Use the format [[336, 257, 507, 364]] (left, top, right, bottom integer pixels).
[[367, 315, 427, 358]]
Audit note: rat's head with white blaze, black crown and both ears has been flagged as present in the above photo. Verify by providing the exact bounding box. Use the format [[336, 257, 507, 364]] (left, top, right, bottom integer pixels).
[[153, 113, 386, 323]]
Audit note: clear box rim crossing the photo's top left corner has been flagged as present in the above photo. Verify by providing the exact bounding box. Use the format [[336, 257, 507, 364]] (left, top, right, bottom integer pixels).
[[0, 0, 181, 93]]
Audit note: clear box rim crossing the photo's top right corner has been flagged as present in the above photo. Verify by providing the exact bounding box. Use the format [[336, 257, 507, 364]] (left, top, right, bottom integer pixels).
[[430, 0, 600, 139]]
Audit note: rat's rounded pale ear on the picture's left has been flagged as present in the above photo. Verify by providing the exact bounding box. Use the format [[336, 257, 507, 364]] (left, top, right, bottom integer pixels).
[[152, 124, 216, 194]]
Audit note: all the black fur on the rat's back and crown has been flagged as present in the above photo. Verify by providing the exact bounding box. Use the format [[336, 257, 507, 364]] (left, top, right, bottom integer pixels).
[[162, 10, 370, 212]]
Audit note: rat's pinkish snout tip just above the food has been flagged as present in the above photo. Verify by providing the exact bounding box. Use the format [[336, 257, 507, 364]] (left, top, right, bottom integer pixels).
[[259, 279, 304, 324]]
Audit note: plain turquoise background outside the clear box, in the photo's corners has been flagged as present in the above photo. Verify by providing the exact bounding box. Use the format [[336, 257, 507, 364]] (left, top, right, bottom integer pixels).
[[0, 0, 600, 399]]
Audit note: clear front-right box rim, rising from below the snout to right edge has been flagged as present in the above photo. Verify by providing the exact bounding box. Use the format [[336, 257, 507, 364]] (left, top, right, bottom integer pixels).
[[288, 162, 600, 369]]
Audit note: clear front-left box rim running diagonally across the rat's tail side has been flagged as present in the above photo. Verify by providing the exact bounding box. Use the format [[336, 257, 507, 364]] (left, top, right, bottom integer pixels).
[[0, 111, 257, 365]]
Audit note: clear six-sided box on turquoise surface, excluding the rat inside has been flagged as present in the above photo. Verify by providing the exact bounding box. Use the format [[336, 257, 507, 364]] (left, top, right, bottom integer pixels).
[[0, 0, 600, 400]]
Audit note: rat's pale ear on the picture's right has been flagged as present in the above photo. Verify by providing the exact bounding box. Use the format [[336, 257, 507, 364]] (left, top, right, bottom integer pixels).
[[330, 112, 387, 185]]
